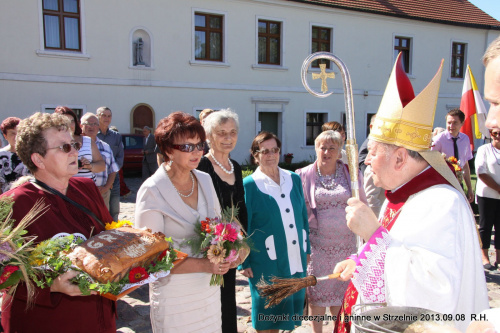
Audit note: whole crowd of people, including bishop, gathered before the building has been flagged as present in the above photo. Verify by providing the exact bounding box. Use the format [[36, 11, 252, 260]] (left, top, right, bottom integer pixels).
[[0, 38, 500, 333]]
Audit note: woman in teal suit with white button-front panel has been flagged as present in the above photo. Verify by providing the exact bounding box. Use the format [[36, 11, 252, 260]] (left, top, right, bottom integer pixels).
[[241, 132, 310, 332]]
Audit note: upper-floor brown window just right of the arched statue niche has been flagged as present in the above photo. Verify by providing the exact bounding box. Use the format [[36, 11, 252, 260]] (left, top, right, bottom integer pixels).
[[194, 13, 223, 61]]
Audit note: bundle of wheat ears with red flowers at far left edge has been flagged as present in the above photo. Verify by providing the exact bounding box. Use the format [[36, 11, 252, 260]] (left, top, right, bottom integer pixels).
[[0, 197, 48, 304]]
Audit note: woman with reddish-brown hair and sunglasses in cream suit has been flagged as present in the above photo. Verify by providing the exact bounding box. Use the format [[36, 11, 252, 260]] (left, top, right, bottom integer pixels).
[[135, 112, 229, 333]]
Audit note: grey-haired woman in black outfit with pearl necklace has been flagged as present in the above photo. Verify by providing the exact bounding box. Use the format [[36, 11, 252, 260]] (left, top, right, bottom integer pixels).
[[198, 109, 247, 333]]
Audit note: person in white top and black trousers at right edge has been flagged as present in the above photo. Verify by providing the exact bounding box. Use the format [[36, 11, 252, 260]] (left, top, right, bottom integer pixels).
[[474, 128, 500, 270]]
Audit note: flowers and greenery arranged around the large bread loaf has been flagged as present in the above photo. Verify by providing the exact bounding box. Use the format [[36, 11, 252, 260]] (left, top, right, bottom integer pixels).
[[29, 221, 187, 300]]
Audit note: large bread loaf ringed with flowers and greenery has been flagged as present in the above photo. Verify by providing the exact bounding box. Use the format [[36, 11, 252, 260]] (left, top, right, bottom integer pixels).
[[30, 222, 183, 299]]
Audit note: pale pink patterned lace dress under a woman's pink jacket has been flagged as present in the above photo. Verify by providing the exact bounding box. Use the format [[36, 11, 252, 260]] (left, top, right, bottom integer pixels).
[[307, 163, 356, 307]]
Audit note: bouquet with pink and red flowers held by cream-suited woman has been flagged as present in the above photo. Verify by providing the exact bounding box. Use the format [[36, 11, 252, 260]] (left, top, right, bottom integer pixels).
[[186, 207, 250, 286]]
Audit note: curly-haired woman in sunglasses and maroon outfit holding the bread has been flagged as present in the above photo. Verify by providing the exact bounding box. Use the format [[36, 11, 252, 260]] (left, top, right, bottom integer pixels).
[[2, 113, 116, 333]]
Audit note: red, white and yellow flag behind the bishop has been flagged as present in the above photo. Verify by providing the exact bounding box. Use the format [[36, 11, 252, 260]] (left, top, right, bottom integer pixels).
[[460, 65, 490, 150]]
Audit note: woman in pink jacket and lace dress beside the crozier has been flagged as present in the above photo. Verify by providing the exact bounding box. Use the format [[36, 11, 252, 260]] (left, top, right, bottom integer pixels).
[[295, 130, 366, 333]]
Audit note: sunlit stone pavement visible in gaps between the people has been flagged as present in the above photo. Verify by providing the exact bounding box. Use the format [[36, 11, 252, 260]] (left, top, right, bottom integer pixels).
[[116, 177, 500, 333]]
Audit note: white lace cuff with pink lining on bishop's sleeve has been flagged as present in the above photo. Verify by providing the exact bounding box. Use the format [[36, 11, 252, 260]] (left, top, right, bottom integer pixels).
[[352, 230, 391, 303]]
